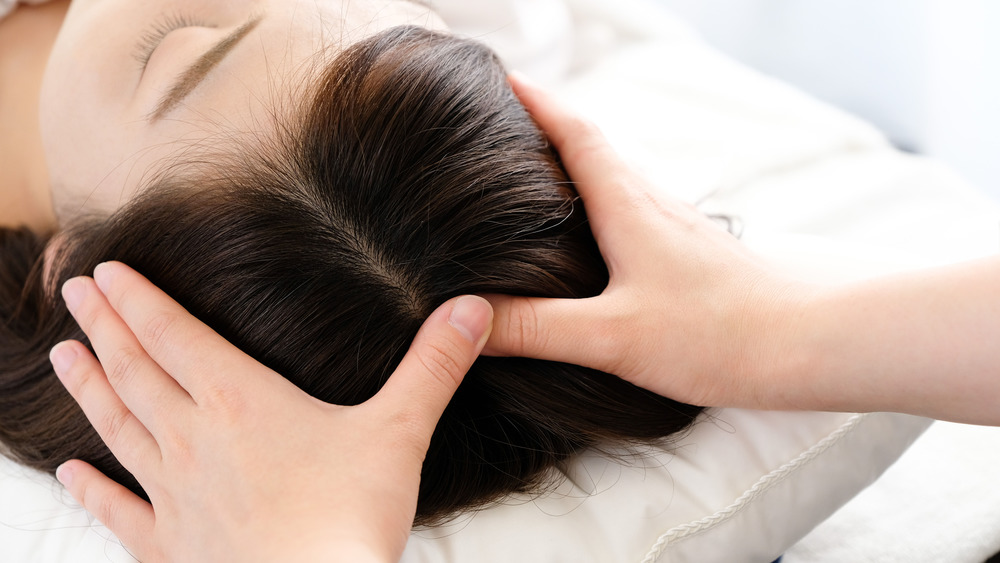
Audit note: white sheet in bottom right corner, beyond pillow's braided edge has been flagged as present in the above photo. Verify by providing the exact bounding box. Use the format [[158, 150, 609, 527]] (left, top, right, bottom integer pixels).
[[783, 422, 1000, 563]]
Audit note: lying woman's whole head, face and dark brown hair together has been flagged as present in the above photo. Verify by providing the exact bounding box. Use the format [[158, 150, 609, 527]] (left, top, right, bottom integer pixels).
[[0, 0, 700, 524]]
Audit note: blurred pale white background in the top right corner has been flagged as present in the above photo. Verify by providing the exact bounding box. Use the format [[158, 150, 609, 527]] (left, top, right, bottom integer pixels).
[[659, 0, 1000, 200]]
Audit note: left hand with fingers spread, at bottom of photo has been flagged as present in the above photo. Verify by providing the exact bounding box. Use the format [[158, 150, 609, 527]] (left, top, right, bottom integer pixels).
[[52, 263, 491, 562]]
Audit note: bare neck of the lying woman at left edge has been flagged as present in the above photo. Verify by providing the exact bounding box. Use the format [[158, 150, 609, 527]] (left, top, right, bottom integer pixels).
[[0, 0, 69, 232]]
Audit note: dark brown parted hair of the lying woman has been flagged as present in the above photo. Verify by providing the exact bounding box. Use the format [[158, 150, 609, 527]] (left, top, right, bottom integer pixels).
[[0, 27, 700, 523]]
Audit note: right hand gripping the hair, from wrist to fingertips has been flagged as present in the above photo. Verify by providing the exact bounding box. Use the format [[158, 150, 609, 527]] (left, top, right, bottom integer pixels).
[[484, 76, 807, 407]]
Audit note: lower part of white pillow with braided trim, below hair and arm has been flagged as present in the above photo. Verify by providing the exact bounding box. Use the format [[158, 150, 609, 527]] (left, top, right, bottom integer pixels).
[[0, 409, 929, 563]]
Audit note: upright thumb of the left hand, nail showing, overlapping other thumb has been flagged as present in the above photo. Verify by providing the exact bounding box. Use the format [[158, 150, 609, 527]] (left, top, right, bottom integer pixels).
[[376, 295, 493, 437]]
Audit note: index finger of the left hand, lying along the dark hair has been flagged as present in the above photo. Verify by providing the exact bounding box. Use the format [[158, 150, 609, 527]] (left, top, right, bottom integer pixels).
[[94, 262, 259, 402]]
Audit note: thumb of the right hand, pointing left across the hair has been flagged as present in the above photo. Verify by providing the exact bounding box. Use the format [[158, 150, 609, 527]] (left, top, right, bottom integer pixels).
[[483, 295, 618, 369]]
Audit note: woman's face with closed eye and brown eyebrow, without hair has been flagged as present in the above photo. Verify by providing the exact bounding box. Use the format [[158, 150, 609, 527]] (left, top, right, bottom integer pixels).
[[41, 0, 443, 222]]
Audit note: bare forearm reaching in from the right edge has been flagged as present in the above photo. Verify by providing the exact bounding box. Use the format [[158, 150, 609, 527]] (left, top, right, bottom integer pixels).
[[761, 257, 1000, 424]]
